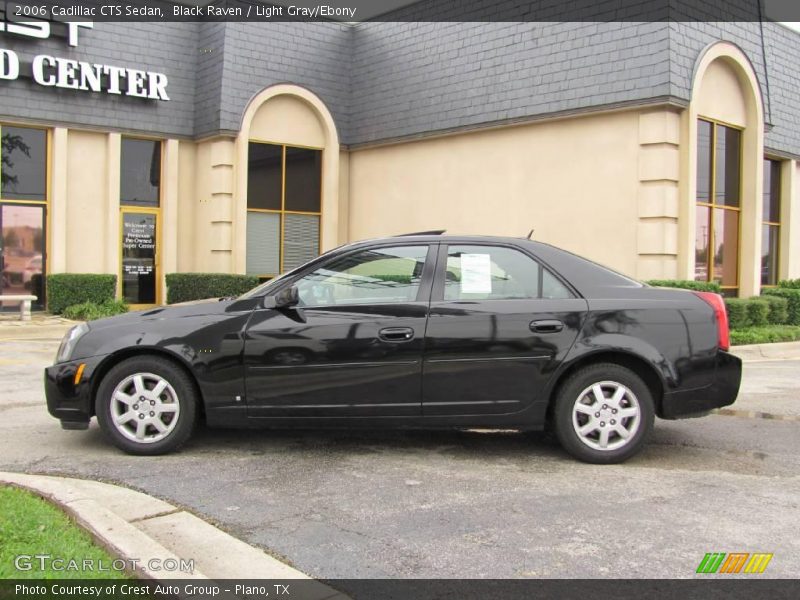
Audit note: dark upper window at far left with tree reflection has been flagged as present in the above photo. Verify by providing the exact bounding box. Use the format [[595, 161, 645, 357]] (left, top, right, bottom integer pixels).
[[0, 126, 47, 201]]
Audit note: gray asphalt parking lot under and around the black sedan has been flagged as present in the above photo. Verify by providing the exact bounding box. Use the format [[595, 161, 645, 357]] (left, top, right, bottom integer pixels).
[[0, 336, 800, 578]]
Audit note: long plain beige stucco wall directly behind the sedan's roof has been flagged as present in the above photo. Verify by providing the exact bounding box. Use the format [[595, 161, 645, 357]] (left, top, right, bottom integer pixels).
[[349, 111, 647, 276]]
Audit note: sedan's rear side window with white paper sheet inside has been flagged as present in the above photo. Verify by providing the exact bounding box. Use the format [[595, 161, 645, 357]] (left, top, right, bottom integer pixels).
[[444, 245, 572, 301]]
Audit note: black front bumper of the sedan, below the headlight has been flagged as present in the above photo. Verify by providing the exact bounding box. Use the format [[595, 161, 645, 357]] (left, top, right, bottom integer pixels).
[[44, 356, 102, 429]]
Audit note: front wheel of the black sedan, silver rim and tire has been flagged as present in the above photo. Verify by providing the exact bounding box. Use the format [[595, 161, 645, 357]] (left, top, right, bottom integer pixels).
[[95, 356, 198, 456]]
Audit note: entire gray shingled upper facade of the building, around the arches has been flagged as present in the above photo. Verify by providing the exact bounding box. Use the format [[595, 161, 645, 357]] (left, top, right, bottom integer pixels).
[[0, 19, 800, 156]]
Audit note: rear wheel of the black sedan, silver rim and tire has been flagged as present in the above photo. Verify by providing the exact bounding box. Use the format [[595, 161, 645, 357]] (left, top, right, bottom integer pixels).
[[553, 363, 655, 464]]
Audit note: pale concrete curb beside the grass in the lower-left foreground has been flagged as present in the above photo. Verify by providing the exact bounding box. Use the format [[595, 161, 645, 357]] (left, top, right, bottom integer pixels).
[[0, 472, 347, 600]]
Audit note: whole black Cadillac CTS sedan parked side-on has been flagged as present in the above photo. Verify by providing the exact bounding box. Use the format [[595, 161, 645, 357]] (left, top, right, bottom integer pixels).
[[45, 235, 742, 463]]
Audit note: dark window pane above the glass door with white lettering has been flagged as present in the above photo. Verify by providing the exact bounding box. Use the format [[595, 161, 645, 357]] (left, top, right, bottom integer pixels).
[[119, 138, 161, 206]]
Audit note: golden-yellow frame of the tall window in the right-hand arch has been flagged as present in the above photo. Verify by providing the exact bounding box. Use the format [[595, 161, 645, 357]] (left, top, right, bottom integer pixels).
[[692, 117, 744, 295]]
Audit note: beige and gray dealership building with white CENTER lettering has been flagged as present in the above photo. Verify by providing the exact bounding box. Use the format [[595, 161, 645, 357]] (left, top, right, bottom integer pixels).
[[0, 16, 800, 305]]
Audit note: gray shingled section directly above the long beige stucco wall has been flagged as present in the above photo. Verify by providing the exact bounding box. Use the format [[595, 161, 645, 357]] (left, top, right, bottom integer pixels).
[[349, 22, 670, 143]]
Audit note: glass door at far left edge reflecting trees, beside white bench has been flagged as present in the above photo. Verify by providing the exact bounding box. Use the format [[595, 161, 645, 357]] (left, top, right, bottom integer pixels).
[[0, 203, 45, 310]]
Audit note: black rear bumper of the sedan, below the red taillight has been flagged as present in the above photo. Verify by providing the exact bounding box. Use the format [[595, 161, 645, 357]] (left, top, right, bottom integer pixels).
[[659, 350, 742, 419]]
